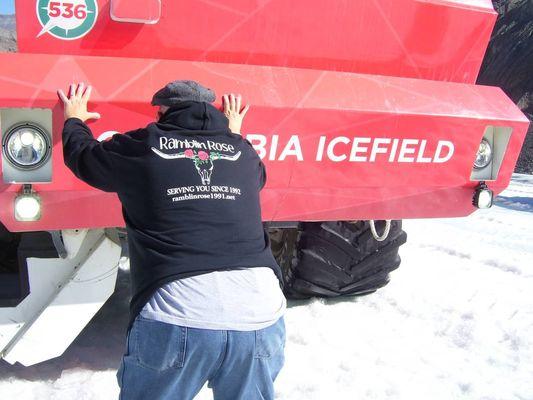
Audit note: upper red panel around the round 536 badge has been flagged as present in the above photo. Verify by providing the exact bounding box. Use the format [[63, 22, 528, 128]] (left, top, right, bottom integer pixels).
[[16, 0, 496, 83]]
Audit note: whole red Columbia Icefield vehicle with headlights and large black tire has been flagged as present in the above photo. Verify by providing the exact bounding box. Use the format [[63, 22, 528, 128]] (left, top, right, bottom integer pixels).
[[0, 0, 529, 365]]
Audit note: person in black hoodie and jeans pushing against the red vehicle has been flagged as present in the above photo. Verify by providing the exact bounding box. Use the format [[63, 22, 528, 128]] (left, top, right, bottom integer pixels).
[[58, 81, 286, 400]]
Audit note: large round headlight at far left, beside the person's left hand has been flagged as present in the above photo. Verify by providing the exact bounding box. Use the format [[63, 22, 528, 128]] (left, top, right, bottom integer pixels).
[[3, 123, 51, 169]]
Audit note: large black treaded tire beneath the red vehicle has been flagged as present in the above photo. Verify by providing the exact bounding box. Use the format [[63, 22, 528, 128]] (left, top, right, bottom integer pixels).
[[271, 221, 407, 299]]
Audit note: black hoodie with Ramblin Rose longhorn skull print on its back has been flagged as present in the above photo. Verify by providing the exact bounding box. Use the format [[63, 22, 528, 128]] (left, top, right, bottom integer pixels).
[[63, 101, 283, 330]]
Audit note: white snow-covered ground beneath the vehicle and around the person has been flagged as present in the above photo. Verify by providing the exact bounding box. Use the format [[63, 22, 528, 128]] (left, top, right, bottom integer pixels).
[[0, 175, 533, 400]]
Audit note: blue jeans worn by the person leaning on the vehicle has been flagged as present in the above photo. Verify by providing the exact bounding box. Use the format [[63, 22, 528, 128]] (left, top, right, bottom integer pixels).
[[117, 315, 285, 400]]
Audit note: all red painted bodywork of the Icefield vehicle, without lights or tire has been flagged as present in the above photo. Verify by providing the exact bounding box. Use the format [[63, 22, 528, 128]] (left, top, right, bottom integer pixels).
[[0, 0, 528, 231]]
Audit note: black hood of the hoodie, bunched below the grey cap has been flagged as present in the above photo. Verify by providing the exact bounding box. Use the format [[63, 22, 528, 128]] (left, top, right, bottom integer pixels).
[[157, 101, 229, 133]]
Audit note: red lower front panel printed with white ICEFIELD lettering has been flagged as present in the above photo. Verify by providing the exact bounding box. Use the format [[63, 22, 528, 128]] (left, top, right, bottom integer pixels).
[[0, 54, 528, 231]]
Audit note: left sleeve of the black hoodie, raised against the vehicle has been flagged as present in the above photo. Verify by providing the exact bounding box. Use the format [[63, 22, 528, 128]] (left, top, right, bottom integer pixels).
[[63, 118, 117, 192]]
